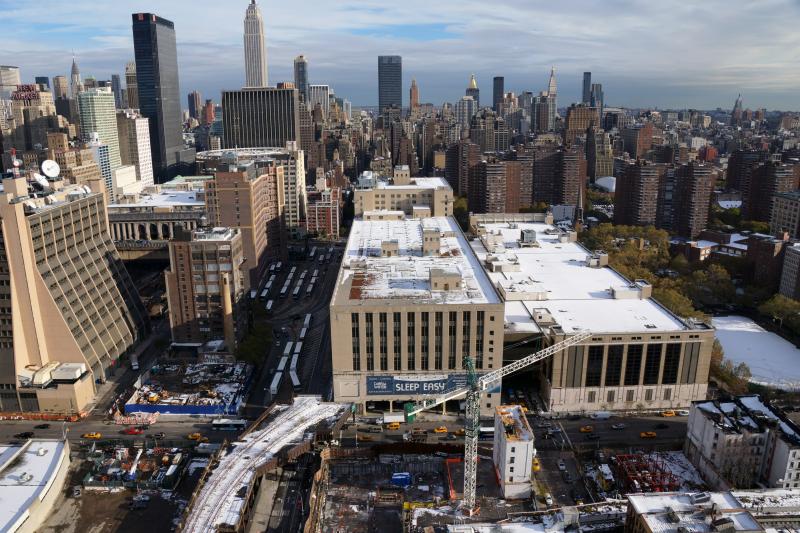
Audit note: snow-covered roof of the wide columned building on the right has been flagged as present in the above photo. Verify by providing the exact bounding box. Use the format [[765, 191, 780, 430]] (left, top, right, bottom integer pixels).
[[471, 222, 687, 334]]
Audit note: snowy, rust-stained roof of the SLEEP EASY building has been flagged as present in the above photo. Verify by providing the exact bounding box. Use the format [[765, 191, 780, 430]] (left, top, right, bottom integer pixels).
[[334, 217, 500, 304]]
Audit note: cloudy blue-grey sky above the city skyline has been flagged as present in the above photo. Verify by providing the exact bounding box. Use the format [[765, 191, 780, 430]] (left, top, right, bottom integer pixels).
[[0, 0, 800, 110]]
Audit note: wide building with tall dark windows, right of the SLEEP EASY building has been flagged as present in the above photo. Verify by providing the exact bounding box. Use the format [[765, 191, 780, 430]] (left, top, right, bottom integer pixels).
[[470, 214, 714, 412]]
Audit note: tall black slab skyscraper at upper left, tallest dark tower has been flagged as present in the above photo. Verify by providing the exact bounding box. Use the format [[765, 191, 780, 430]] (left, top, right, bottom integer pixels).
[[133, 13, 194, 182]]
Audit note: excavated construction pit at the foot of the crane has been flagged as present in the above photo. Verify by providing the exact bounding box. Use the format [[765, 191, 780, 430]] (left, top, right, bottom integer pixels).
[[307, 444, 534, 533]]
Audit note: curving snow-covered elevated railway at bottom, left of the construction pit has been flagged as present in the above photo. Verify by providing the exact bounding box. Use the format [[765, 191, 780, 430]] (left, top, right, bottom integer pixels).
[[183, 396, 344, 532]]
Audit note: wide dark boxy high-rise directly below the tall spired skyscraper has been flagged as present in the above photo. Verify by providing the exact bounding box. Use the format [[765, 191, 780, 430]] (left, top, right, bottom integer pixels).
[[222, 87, 300, 148]]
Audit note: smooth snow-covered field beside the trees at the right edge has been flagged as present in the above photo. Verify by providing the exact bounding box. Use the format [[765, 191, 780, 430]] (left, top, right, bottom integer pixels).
[[712, 316, 800, 390]]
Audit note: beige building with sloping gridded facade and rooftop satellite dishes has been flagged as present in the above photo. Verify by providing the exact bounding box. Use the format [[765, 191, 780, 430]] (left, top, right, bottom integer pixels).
[[0, 178, 147, 413]]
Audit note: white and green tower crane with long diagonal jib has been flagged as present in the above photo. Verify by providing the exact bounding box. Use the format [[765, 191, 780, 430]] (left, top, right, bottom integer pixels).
[[406, 332, 591, 515]]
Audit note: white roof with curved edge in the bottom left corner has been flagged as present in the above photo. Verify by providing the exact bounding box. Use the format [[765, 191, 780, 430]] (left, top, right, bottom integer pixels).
[[0, 439, 67, 531]]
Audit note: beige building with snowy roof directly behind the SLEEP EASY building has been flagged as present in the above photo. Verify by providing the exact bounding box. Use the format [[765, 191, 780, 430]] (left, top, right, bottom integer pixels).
[[353, 170, 453, 217]]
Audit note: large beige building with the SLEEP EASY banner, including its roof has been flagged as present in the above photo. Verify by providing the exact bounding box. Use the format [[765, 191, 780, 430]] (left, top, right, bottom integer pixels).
[[330, 217, 503, 416]]
